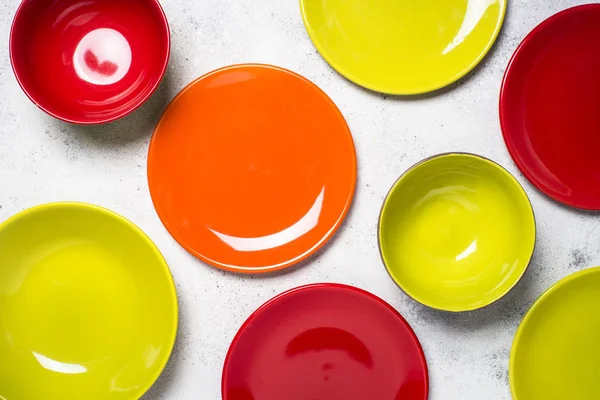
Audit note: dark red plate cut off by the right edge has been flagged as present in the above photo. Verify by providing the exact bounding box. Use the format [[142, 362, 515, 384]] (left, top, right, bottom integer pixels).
[[500, 4, 600, 210]]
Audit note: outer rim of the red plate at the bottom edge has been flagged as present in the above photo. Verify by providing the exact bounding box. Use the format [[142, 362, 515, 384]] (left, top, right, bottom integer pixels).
[[221, 282, 430, 399]]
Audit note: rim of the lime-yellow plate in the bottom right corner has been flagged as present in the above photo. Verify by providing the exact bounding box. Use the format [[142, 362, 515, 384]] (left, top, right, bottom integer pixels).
[[508, 266, 600, 400]]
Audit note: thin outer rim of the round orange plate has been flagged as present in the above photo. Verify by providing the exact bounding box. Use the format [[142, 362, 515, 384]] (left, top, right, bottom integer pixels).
[[146, 63, 358, 275]]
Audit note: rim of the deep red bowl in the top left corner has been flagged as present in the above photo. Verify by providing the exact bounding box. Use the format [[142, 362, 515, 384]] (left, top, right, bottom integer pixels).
[[8, 0, 171, 125]]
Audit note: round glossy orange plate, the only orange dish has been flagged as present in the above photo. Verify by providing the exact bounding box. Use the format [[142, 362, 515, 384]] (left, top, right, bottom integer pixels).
[[148, 65, 356, 272]]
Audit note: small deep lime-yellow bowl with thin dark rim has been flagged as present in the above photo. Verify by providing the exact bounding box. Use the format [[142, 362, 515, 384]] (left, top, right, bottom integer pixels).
[[379, 154, 535, 311]]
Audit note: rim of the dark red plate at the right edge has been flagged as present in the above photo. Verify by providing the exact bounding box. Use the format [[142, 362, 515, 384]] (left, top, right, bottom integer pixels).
[[498, 3, 600, 212]]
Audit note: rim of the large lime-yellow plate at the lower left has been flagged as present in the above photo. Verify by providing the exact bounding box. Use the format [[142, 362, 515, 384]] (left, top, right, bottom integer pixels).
[[0, 201, 179, 400]]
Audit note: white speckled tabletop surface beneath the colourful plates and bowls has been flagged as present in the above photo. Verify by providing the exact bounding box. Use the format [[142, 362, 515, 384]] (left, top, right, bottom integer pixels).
[[0, 0, 600, 400]]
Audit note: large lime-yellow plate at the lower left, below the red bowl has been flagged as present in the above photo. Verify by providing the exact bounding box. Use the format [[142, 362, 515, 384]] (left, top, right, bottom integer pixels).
[[0, 203, 177, 400]]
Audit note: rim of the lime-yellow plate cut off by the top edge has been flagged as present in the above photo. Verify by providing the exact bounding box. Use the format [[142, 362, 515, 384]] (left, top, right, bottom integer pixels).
[[298, 0, 508, 96]]
